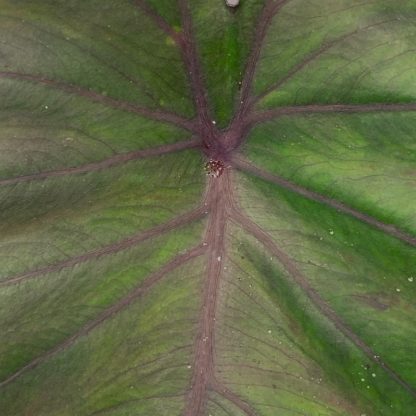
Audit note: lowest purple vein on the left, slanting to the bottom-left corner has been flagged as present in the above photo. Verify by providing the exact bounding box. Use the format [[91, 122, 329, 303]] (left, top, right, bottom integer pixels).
[[0, 242, 206, 387]]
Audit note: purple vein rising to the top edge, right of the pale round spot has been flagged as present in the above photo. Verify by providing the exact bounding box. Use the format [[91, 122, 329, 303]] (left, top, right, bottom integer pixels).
[[235, 0, 288, 122]]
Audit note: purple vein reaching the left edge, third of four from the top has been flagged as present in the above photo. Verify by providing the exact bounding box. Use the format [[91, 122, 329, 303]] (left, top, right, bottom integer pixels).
[[0, 207, 204, 287]]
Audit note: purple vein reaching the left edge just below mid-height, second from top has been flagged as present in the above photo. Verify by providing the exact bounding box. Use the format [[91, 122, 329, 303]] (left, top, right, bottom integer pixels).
[[0, 139, 200, 186]]
